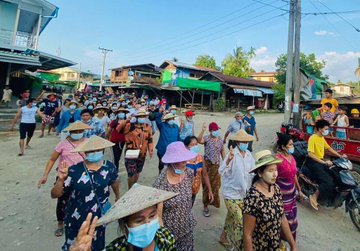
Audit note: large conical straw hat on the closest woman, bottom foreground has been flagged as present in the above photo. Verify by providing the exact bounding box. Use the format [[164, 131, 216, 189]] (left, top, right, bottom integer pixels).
[[97, 184, 178, 226]]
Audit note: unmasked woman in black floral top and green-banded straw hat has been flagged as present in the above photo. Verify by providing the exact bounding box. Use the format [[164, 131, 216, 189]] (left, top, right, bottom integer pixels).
[[243, 150, 297, 251]]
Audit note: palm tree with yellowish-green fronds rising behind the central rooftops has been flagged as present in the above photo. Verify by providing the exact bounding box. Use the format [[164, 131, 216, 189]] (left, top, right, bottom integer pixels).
[[221, 47, 255, 78]]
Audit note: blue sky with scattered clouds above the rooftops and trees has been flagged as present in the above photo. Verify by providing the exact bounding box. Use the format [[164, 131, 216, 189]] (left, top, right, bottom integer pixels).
[[39, 0, 360, 82]]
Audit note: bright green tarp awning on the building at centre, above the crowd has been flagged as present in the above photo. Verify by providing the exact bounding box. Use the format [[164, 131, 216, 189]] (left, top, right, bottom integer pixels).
[[176, 78, 221, 92]]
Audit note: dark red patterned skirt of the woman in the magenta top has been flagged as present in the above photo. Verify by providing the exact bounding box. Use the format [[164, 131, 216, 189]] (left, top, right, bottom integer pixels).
[[276, 179, 298, 240]]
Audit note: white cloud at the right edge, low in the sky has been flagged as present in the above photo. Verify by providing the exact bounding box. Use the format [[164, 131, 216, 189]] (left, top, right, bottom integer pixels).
[[318, 51, 360, 83]]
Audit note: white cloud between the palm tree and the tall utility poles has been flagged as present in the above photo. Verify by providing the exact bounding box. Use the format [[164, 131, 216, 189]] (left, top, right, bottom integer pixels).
[[250, 46, 276, 71]]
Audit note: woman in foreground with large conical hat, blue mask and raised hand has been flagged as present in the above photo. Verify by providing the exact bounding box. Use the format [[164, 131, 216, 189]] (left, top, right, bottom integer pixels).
[[70, 184, 177, 251]]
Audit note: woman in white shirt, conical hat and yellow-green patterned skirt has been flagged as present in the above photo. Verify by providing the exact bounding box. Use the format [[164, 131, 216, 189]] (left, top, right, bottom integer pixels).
[[219, 129, 255, 250]]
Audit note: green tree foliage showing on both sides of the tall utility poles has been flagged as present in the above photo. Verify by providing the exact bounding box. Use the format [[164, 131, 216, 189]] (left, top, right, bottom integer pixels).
[[275, 53, 329, 84]]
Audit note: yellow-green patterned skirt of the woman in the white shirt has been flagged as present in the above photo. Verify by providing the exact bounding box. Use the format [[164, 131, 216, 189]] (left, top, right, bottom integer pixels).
[[224, 199, 243, 250]]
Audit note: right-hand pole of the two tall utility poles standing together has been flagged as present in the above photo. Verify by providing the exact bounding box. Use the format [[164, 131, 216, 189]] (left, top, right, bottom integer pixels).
[[293, 0, 301, 128]]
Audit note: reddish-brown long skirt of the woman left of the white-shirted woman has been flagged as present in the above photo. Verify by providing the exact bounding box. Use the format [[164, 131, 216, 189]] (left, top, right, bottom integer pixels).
[[202, 160, 221, 208]]
